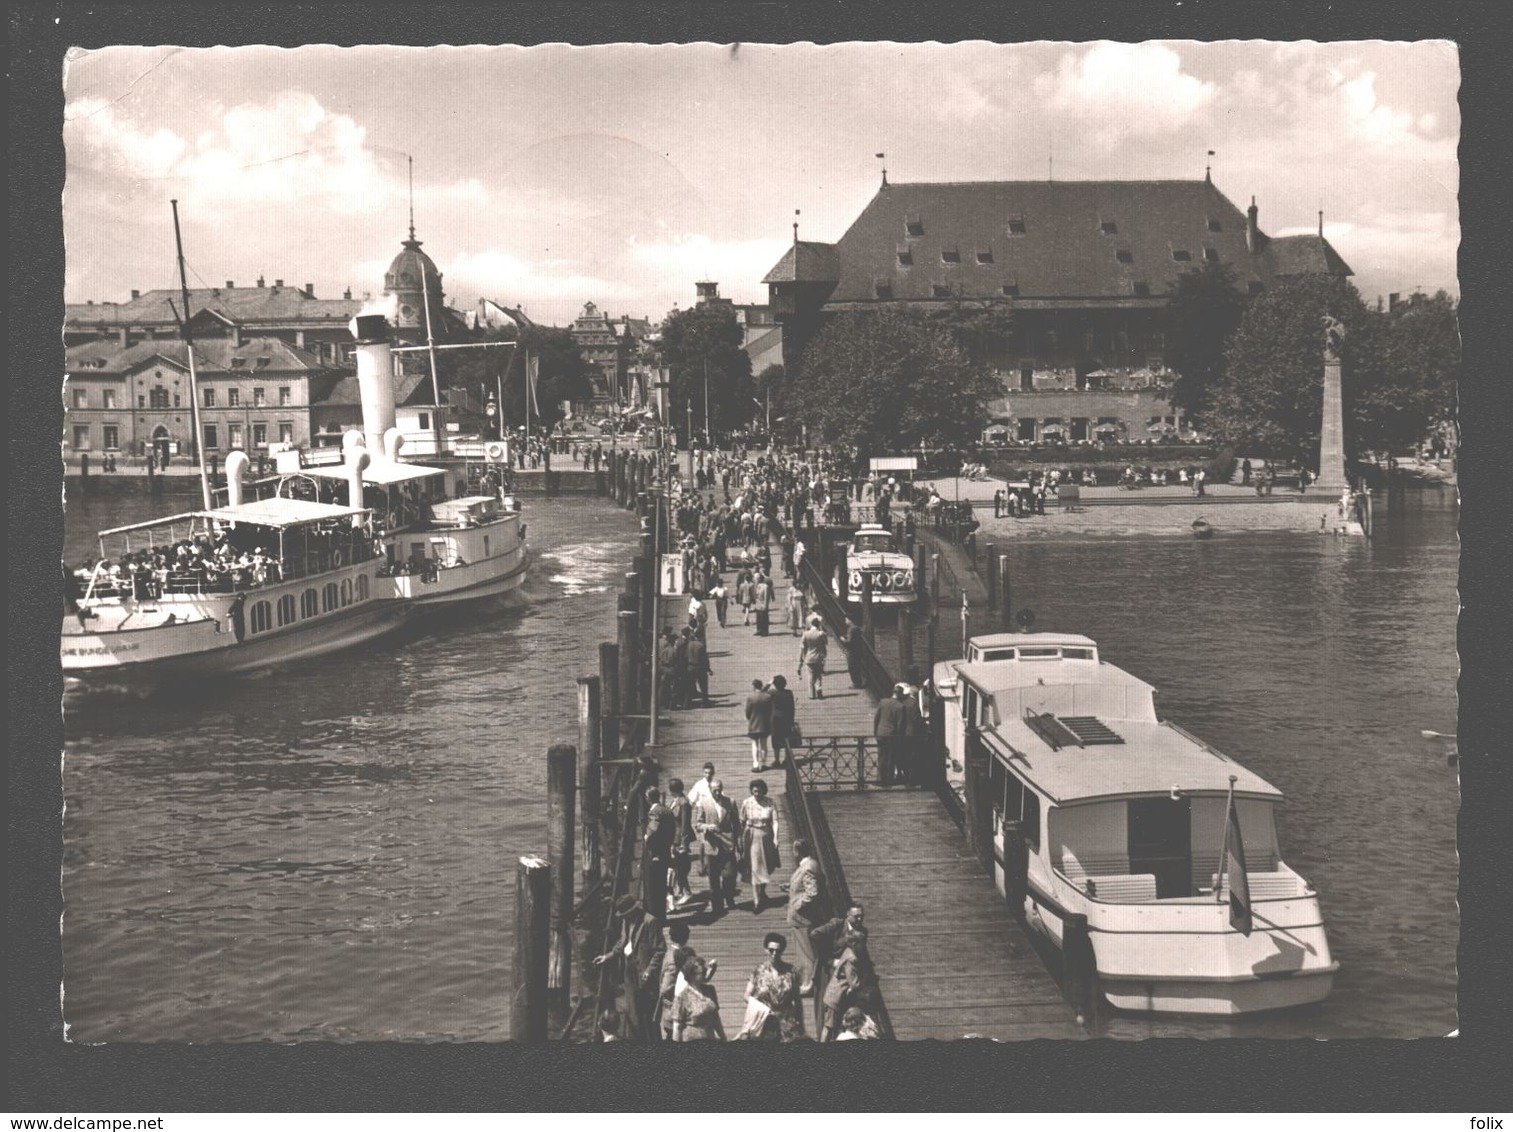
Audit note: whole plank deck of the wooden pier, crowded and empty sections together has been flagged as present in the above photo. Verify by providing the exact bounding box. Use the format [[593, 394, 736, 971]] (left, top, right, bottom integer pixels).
[[620, 548, 1083, 1040]]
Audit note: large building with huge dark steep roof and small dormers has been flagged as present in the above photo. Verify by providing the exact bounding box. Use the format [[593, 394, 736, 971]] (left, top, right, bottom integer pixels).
[[763, 177, 1351, 440]]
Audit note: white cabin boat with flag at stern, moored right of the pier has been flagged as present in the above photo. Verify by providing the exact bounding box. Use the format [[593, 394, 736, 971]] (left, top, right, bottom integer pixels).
[[934, 633, 1339, 1014]]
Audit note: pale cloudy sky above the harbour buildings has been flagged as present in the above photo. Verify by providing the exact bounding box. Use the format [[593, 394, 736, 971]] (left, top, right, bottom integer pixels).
[[62, 41, 1460, 325]]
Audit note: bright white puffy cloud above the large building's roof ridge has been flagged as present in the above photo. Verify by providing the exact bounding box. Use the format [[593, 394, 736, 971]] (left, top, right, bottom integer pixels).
[[1033, 42, 1215, 132]]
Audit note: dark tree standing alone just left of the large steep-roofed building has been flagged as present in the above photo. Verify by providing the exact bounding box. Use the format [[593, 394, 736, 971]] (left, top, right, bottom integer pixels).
[[660, 303, 755, 433]]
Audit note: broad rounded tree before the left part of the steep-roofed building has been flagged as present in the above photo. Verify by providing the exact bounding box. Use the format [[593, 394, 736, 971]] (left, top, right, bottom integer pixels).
[[784, 309, 1003, 456]]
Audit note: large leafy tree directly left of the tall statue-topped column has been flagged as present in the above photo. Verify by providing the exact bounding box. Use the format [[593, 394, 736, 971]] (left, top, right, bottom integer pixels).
[[1204, 277, 1369, 460]]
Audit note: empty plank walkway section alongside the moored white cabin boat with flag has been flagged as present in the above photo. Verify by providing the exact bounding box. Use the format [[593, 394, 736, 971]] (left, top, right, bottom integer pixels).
[[819, 790, 1086, 1040]]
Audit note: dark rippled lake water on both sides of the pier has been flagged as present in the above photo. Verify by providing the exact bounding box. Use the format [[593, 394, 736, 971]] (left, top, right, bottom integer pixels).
[[62, 490, 1459, 1041]]
